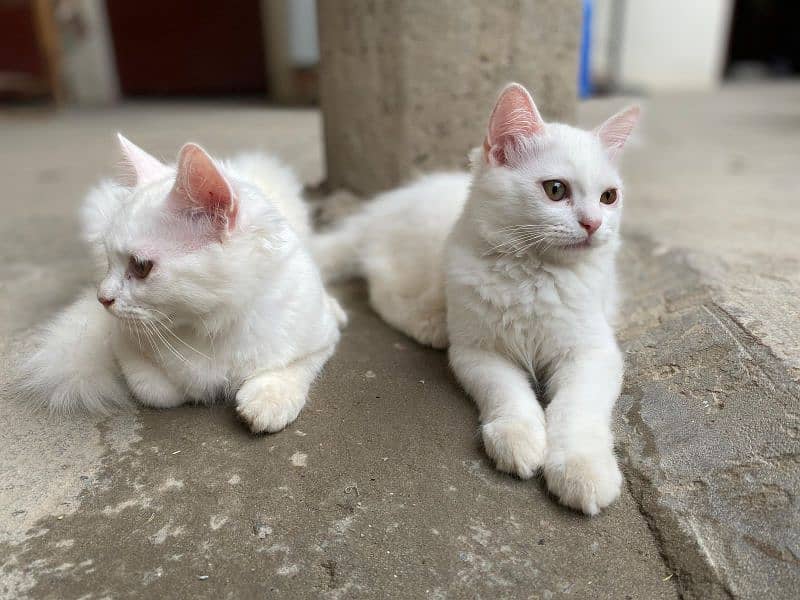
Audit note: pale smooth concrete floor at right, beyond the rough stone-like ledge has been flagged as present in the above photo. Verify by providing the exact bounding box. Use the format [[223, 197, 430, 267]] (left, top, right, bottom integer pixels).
[[604, 83, 800, 382]]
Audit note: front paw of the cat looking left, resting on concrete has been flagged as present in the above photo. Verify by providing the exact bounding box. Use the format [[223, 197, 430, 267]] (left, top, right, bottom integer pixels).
[[236, 373, 307, 433]]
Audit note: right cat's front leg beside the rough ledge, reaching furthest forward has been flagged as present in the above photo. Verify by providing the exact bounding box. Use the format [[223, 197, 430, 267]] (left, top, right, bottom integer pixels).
[[544, 341, 623, 515]]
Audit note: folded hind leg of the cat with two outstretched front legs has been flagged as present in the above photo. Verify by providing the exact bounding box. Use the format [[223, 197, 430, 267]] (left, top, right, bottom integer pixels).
[[369, 277, 447, 348]]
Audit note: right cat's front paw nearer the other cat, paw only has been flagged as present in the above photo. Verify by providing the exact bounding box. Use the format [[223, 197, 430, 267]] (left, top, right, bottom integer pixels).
[[481, 417, 547, 479]]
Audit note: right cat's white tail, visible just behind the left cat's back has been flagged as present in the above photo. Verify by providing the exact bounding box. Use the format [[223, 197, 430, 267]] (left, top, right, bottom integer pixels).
[[311, 215, 363, 282]]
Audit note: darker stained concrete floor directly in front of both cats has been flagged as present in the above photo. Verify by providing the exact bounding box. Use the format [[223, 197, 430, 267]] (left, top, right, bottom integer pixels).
[[1, 286, 675, 598]]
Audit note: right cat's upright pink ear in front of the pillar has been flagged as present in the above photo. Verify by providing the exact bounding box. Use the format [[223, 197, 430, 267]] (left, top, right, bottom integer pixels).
[[483, 83, 544, 165]]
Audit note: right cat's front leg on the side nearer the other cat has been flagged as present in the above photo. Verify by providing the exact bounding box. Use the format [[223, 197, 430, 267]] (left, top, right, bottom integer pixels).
[[450, 344, 547, 478]]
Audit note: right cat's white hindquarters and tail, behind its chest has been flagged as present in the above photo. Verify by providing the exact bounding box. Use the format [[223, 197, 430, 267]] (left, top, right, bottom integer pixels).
[[312, 173, 462, 348]]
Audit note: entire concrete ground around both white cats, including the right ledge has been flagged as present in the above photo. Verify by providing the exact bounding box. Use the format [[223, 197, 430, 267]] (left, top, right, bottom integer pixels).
[[0, 85, 800, 599]]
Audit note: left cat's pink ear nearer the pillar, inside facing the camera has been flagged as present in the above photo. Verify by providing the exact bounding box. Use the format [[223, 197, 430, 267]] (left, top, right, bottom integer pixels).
[[170, 143, 239, 234]]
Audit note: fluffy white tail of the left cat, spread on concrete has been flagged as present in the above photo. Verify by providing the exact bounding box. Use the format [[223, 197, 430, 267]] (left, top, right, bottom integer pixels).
[[19, 290, 130, 413]]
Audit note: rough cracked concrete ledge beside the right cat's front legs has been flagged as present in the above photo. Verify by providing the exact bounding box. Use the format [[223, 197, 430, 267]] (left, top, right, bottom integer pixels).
[[619, 238, 800, 600]]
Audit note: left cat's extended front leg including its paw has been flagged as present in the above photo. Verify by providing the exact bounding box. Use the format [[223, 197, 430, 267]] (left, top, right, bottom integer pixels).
[[236, 345, 334, 433]]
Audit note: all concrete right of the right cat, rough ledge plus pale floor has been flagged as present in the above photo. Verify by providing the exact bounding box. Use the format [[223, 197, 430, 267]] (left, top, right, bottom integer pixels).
[[580, 85, 800, 598]]
